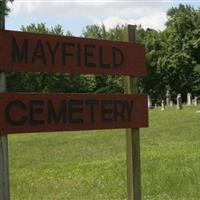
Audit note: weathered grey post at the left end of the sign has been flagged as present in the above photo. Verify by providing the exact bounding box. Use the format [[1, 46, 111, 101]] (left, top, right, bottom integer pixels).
[[0, 0, 10, 200]]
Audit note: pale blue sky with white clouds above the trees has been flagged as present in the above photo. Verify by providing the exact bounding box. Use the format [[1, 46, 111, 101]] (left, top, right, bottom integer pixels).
[[6, 0, 200, 36]]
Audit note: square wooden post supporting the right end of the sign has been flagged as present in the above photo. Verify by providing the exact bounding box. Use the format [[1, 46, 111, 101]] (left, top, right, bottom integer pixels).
[[124, 25, 141, 200]]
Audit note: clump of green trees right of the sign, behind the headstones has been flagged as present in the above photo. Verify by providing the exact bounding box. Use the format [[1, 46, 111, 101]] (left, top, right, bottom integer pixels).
[[137, 5, 200, 101]]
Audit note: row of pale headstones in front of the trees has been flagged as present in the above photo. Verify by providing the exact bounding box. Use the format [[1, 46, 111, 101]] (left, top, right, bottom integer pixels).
[[148, 90, 198, 110]]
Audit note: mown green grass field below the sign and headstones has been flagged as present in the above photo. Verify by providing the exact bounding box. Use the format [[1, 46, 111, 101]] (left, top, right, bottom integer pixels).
[[9, 106, 200, 200]]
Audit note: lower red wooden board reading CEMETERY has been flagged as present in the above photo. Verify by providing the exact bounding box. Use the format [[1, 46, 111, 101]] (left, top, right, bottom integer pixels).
[[0, 93, 148, 134]]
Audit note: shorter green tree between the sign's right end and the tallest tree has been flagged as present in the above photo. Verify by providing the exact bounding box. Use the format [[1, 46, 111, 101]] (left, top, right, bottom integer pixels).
[[137, 29, 166, 102]]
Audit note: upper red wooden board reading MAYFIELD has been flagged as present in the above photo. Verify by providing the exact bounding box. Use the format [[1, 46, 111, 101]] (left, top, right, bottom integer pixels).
[[0, 31, 146, 77]]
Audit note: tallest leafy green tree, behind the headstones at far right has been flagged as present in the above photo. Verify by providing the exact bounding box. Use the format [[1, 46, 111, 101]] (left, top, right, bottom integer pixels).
[[159, 5, 200, 100]]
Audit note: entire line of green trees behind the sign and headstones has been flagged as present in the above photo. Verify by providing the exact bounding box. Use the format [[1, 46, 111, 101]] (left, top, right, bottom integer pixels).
[[0, 4, 200, 103]]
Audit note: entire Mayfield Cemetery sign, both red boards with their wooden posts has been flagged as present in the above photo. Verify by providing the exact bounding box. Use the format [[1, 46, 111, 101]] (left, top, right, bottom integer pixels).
[[0, 21, 148, 200]]
